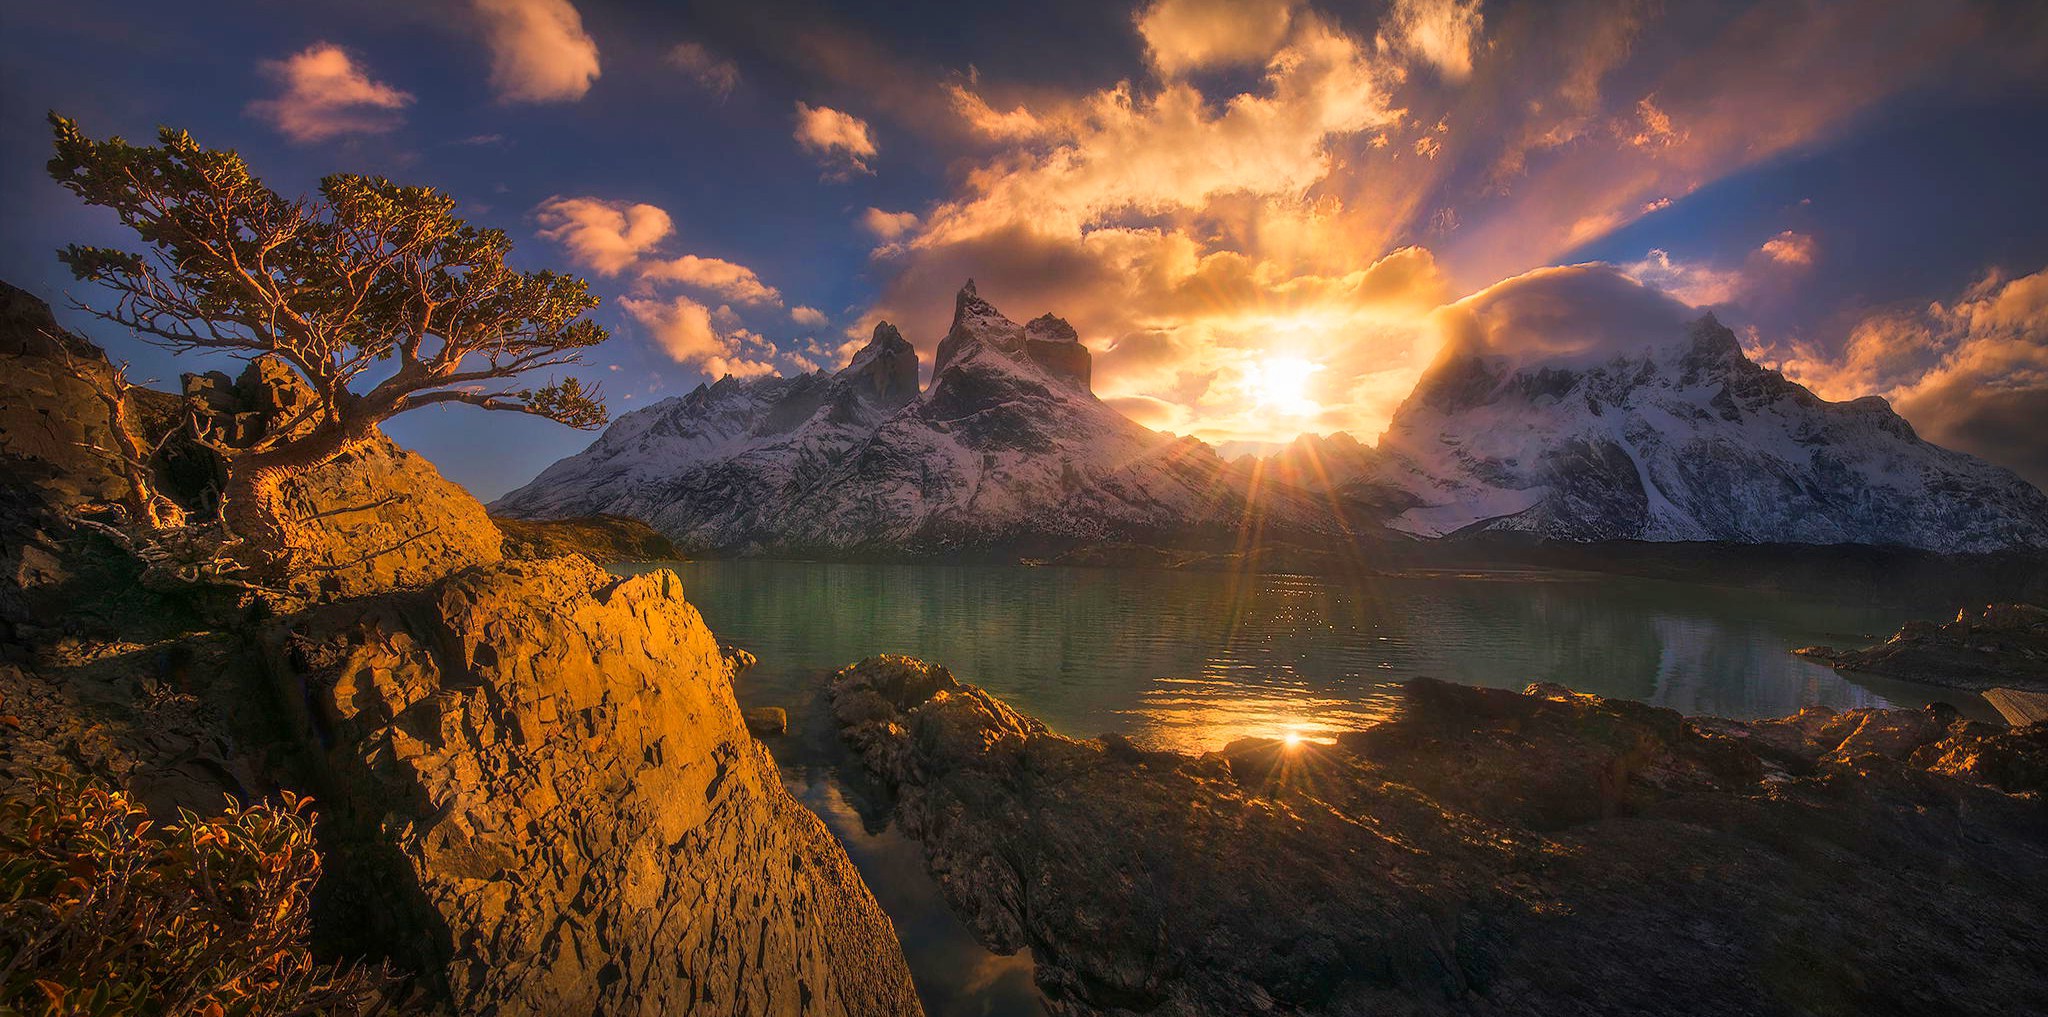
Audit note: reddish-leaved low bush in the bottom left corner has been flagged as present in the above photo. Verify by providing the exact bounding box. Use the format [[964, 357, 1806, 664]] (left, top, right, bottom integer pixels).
[[0, 773, 397, 1017]]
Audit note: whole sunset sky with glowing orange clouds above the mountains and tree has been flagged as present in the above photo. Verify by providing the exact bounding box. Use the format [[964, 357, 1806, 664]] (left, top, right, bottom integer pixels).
[[0, 0, 2048, 499]]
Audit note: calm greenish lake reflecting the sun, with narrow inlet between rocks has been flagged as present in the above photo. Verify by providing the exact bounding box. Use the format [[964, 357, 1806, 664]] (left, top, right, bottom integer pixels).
[[614, 561, 1985, 1017]]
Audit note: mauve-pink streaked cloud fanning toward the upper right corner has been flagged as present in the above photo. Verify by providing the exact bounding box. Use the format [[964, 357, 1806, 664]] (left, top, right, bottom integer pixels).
[[1449, 0, 2007, 280]]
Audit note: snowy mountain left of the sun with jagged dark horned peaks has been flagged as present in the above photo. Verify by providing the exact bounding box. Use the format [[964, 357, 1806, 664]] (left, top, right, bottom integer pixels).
[[492, 280, 1331, 555]]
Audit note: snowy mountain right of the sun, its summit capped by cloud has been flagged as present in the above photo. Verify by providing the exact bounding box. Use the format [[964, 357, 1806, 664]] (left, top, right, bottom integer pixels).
[[1343, 270, 2048, 552]]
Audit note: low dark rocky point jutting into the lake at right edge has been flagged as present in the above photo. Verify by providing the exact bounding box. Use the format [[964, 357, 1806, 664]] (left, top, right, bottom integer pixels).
[[1792, 604, 2048, 692]]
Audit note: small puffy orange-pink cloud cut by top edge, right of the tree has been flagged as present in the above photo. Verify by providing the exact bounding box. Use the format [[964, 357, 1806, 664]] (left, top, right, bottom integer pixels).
[[471, 0, 598, 102]]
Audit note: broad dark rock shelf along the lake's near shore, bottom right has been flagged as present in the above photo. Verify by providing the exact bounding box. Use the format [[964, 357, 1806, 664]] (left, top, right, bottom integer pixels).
[[831, 657, 2048, 1015]]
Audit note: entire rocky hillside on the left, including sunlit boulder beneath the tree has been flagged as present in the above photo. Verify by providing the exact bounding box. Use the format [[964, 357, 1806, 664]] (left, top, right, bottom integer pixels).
[[0, 280, 920, 1017]]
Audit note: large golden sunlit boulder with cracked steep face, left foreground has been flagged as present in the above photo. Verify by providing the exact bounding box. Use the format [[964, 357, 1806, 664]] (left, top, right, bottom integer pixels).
[[270, 559, 920, 1015]]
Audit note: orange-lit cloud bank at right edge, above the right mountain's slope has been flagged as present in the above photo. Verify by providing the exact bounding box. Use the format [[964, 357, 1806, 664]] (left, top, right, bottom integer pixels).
[[1757, 268, 2048, 489]]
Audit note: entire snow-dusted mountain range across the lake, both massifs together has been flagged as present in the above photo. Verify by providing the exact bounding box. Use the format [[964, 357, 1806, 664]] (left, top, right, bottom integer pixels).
[[492, 282, 2048, 557]]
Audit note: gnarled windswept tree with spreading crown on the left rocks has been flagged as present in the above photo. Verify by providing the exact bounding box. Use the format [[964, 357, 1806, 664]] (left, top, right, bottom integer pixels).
[[49, 113, 608, 563]]
